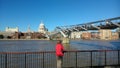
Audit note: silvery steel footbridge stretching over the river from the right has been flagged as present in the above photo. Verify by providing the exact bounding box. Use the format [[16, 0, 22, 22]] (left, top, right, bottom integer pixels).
[[48, 17, 120, 37]]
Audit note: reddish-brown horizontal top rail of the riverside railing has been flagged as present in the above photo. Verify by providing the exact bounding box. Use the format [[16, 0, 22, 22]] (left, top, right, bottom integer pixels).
[[0, 50, 120, 54]]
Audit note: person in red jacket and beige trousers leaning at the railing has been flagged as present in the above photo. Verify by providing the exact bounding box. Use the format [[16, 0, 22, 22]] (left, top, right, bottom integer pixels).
[[56, 40, 64, 68]]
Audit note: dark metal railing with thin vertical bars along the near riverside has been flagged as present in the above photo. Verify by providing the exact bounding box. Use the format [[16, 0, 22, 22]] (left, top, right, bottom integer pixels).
[[0, 50, 120, 68]]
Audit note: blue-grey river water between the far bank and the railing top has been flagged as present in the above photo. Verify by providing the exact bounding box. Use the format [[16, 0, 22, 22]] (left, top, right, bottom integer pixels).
[[0, 40, 120, 52]]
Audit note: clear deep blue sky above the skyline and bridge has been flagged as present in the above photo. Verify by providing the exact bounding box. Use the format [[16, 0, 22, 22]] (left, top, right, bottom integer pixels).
[[0, 0, 120, 32]]
